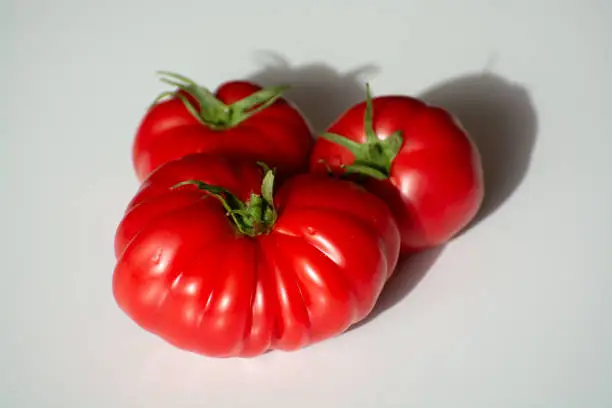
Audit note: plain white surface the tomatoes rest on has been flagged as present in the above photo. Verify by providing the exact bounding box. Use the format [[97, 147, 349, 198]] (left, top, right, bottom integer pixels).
[[0, 0, 612, 408]]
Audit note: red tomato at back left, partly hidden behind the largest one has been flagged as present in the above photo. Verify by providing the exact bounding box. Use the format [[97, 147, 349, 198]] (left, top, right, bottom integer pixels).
[[132, 72, 314, 181]]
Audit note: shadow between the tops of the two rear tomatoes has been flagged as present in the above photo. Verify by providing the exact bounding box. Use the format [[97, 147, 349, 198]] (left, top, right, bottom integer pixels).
[[248, 52, 379, 135]]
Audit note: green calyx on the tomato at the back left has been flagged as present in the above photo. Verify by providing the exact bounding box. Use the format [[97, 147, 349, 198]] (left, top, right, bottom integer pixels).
[[154, 71, 288, 130]]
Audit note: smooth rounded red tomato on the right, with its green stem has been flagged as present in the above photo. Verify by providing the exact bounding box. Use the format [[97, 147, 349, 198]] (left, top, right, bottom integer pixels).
[[310, 86, 484, 253]]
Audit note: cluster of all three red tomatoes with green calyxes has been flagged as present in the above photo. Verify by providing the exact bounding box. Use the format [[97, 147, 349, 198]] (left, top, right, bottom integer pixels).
[[113, 73, 484, 357]]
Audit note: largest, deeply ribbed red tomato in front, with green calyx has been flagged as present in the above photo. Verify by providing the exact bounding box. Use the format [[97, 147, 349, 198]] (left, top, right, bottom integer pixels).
[[113, 155, 400, 357]]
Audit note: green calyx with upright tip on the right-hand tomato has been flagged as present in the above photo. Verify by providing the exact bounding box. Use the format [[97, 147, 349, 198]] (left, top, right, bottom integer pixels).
[[321, 84, 403, 180]]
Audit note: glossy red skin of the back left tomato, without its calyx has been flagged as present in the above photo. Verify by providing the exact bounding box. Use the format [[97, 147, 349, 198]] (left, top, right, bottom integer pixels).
[[132, 81, 314, 181]]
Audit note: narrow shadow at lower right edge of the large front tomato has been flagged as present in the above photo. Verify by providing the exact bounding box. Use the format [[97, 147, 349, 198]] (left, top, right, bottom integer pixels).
[[349, 245, 444, 331]]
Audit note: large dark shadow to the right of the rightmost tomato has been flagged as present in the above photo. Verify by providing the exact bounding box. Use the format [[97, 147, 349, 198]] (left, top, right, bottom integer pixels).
[[419, 73, 538, 228]]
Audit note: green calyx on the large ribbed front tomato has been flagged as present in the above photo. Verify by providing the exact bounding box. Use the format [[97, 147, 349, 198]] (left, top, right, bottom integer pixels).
[[172, 166, 278, 237]]
